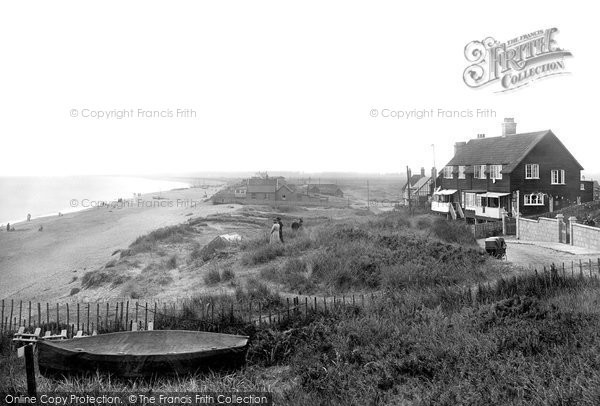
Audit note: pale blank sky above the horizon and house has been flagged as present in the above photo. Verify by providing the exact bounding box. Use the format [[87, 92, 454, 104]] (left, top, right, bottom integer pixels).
[[0, 0, 600, 176]]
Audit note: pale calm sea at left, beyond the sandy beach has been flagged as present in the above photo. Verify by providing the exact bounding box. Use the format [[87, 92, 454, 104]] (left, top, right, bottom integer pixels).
[[0, 176, 191, 226]]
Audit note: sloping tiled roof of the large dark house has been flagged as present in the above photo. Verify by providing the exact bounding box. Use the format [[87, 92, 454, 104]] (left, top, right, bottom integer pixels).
[[447, 130, 575, 173]]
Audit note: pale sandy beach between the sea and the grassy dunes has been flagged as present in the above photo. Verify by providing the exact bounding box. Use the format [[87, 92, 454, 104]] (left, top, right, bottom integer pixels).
[[0, 184, 233, 300]]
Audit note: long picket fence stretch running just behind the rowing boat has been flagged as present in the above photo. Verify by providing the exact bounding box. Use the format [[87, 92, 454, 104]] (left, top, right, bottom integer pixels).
[[0, 293, 376, 338]]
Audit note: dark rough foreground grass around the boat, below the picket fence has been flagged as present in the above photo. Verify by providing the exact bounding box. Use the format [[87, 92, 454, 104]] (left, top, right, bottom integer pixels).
[[0, 272, 600, 406]]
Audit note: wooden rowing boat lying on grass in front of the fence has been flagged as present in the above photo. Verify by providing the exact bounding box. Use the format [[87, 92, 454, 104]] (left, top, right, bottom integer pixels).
[[38, 330, 248, 378]]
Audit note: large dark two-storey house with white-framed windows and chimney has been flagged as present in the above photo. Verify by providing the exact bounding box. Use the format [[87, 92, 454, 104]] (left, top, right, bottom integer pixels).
[[431, 118, 591, 222]]
